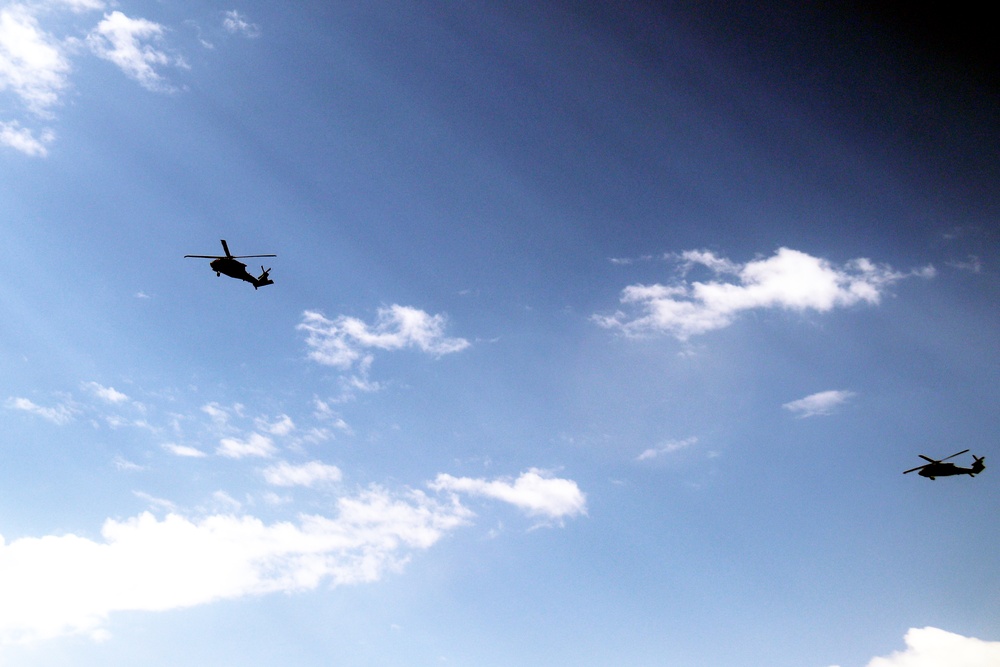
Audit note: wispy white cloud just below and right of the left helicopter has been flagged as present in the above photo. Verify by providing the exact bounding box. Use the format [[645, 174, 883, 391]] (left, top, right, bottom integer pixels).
[[298, 304, 469, 379]]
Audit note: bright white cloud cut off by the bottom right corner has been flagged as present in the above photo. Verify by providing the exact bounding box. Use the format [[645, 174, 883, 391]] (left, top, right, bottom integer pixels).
[[852, 627, 1000, 667]]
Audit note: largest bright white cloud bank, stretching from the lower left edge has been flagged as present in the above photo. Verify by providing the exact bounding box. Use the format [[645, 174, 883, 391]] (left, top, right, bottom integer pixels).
[[0, 488, 470, 643]]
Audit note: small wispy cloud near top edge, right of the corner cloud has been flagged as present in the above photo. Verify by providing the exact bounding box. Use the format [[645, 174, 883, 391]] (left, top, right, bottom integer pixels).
[[87, 11, 186, 92]]
